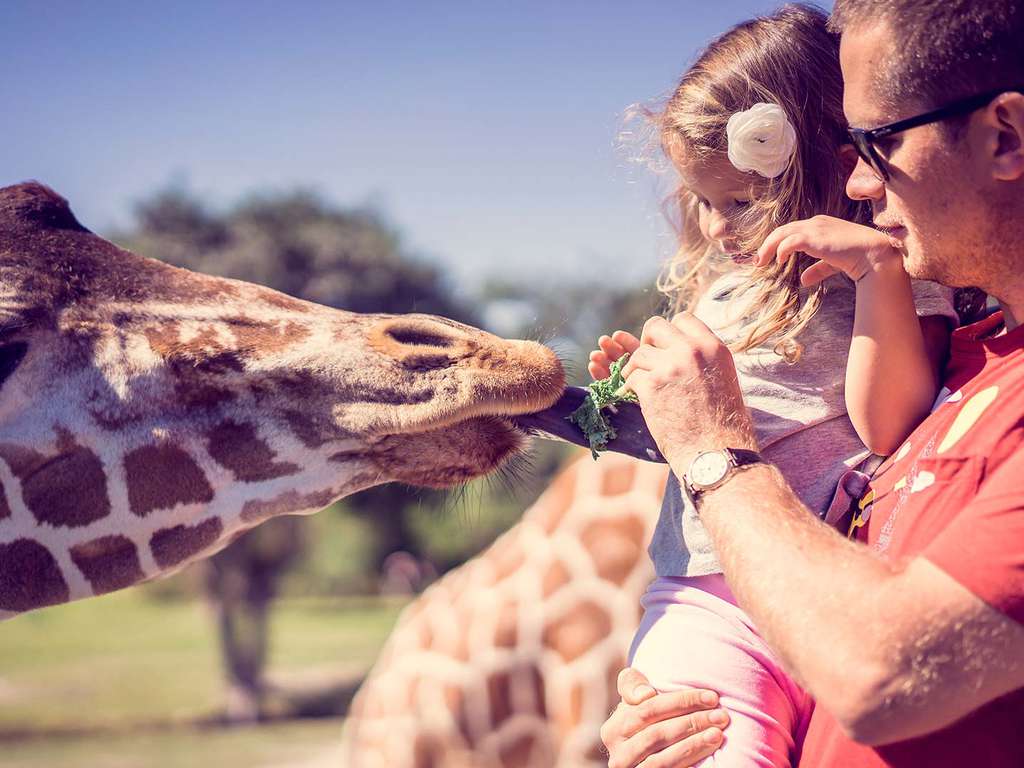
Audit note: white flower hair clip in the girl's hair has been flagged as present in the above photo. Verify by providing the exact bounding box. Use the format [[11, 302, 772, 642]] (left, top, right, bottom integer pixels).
[[725, 101, 797, 178]]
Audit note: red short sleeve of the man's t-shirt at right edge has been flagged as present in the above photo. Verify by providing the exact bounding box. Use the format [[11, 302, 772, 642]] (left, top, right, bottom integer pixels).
[[923, 442, 1024, 624]]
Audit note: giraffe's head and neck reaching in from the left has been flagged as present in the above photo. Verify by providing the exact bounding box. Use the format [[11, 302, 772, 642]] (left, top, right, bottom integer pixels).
[[0, 182, 564, 620]]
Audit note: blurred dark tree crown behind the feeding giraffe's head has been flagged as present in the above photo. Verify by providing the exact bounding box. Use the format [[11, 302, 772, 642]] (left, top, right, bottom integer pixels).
[[115, 188, 477, 325]]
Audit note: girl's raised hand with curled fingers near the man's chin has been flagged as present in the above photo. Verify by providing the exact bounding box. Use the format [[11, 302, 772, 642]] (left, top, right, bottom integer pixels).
[[754, 216, 903, 286]]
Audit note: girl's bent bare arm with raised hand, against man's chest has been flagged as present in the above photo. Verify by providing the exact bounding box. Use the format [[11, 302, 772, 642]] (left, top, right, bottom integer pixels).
[[757, 216, 949, 455]]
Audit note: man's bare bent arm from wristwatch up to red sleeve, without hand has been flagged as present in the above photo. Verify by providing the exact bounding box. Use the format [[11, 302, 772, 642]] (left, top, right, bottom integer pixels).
[[700, 466, 1024, 744]]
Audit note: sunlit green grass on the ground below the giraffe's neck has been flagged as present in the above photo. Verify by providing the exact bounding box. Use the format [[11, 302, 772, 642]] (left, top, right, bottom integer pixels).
[[0, 588, 402, 757]]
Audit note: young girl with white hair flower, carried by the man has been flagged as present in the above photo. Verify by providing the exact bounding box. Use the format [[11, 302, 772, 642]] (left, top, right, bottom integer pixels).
[[590, 6, 956, 766]]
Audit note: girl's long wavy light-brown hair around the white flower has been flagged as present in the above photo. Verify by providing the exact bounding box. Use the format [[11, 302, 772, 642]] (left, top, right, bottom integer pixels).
[[650, 4, 867, 361]]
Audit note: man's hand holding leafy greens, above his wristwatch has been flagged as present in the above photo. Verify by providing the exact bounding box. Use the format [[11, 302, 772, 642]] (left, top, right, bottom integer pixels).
[[610, 313, 757, 474]]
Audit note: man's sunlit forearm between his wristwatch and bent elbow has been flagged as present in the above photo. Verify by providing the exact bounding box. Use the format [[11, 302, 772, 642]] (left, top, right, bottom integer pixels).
[[679, 466, 895, 729]]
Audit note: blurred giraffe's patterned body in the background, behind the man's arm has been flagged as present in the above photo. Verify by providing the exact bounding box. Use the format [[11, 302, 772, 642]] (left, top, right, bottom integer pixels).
[[336, 454, 668, 768]]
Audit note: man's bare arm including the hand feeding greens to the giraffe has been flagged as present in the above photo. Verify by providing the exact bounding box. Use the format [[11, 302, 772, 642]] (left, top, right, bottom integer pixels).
[[624, 315, 1024, 743]]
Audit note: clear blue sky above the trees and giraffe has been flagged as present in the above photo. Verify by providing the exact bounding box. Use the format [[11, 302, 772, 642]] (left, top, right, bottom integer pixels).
[[0, 0, 823, 286]]
